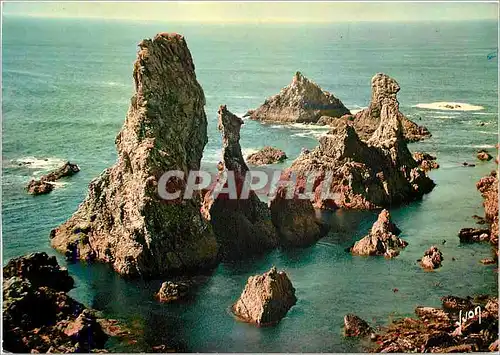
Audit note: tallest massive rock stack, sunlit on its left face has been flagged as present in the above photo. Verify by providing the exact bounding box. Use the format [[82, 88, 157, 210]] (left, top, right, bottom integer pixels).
[[51, 33, 217, 276]]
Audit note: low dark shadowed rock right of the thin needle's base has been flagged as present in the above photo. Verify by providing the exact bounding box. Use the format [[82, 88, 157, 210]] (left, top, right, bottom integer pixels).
[[269, 169, 326, 247]]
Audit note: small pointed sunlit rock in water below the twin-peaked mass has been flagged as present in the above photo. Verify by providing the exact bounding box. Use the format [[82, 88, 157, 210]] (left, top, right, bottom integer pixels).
[[351, 210, 408, 258]]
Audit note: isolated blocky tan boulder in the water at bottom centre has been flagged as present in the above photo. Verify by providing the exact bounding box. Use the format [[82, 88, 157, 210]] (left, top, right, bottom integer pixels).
[[232, 267, 297, 326]]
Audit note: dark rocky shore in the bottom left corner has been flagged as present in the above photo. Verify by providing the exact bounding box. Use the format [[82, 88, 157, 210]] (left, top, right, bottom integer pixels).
[[2, 253, 108, 353]]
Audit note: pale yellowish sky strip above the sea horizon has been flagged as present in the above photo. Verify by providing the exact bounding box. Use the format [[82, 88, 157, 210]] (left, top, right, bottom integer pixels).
[[3, 1, 498, 23]]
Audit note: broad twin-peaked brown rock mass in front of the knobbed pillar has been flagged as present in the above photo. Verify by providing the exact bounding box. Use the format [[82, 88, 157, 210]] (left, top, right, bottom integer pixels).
[[290, 108, 435, 209]]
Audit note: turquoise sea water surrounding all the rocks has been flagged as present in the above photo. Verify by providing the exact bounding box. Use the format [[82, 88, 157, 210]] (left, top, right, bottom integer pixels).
[[2, 17, 498, 352]]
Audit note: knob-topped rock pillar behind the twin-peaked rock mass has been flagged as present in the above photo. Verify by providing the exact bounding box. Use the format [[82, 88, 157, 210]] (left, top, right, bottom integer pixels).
[[320, 73, 431, 142]]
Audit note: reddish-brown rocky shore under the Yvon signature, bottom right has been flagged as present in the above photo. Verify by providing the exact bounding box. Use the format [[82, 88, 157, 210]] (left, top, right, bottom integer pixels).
[[370, 296, 498, 353]]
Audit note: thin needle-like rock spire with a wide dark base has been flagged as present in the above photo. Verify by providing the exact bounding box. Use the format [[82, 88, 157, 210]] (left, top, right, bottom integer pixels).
[[202, 106, 278, 259]]
